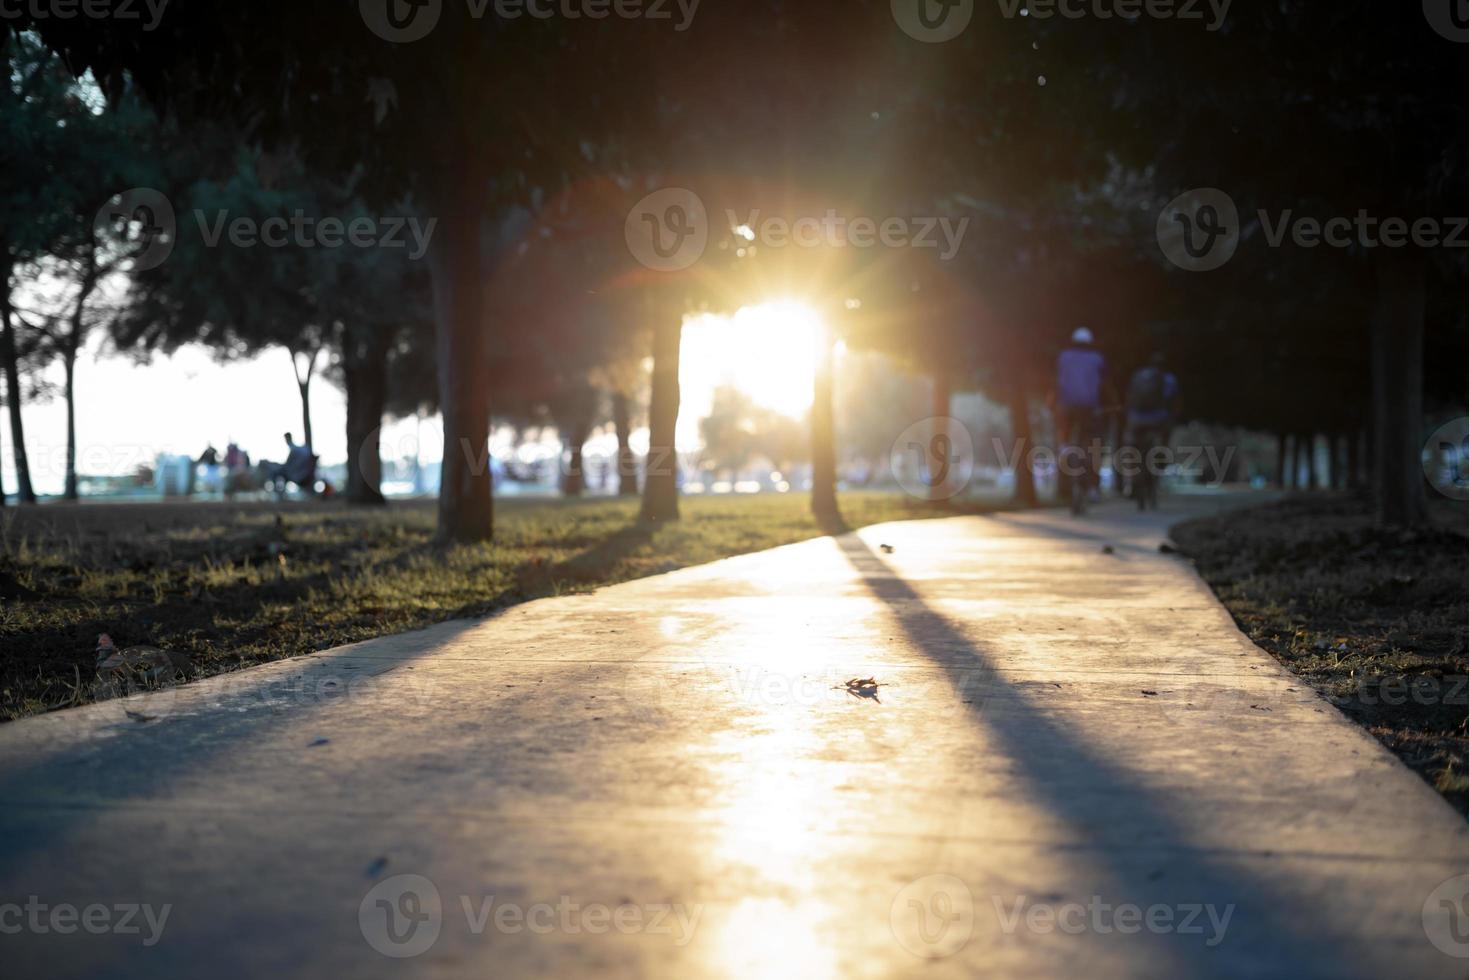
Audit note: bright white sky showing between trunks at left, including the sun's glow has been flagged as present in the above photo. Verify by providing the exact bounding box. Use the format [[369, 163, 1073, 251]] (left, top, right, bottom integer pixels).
[[0, 303, 818, 494]]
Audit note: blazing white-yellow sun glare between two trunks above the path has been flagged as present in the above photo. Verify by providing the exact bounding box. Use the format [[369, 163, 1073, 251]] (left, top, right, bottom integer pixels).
[[679, 300, 821, 447]]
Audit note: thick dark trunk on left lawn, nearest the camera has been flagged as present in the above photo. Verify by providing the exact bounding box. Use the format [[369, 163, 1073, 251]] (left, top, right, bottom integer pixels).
[[430, 176, 495, 542]]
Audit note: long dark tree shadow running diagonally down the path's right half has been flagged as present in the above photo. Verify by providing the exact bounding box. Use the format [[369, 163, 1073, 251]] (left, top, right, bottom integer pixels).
[[836, 533, 1362, 979]]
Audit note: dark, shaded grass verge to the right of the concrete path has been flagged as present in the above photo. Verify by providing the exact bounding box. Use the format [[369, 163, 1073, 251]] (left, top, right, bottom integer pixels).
[[1172, 494, 1469, 815]]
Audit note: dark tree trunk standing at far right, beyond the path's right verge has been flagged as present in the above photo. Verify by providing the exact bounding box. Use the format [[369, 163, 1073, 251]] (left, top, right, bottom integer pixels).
[[1372, 248, 1425, 527]]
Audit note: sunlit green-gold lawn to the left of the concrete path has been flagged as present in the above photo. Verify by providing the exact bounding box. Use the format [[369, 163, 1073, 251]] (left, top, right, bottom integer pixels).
[[0, 494, 995, 720]]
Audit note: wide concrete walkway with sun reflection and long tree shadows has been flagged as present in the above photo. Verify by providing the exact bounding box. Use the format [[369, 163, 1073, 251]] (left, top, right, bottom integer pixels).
[[0, 502, 1469, 980]]
